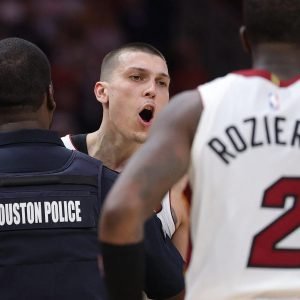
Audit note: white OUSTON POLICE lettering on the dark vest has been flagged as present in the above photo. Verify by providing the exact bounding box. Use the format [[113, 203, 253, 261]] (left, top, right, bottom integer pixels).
[[0, 200, 82, 227]]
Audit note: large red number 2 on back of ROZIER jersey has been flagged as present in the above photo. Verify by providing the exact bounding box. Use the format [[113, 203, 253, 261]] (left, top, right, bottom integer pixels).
[[248, 178, 300, 268]]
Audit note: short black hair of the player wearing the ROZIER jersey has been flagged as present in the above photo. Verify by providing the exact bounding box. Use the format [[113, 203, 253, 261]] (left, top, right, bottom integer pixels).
[[243, 0, 300, 43]]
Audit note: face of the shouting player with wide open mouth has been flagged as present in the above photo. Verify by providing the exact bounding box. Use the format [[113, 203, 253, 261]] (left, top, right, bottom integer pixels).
[[108, 52, 170, 143]]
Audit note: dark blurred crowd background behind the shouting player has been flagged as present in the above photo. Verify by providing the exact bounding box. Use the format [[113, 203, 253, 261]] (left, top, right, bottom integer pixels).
[[0, 0, 250, 134]]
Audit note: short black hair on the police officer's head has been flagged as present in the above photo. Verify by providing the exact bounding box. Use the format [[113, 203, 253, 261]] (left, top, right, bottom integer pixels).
[[0, 37, 51, 110]]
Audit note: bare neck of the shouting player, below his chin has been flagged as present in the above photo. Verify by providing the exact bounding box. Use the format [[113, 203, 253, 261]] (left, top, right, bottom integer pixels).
[[87, 128, 137, 172]]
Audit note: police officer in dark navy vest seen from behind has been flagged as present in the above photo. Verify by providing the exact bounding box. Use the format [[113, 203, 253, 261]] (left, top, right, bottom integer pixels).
[[0, 38, 114, 300]]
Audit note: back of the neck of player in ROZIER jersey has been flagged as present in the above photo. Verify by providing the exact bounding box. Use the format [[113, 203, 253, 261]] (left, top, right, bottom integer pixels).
[[252, 43, 300, 80]]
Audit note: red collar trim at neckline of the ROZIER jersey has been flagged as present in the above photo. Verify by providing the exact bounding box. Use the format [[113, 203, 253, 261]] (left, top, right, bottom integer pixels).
[[232, 69, 300, 87]]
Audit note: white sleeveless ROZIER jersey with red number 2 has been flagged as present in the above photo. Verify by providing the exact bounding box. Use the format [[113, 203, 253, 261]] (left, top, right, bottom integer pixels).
[[186, 70, 300, 300]]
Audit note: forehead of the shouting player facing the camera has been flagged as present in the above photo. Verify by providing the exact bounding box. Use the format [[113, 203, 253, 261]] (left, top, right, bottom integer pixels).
[[116, 50, 169, 76]]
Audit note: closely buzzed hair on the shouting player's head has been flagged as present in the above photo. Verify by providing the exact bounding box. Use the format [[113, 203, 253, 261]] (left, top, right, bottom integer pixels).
[[100, 42, 166, 80]]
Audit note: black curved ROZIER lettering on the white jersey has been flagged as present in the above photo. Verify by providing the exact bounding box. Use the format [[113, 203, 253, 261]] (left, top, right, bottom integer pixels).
[[208, 116, 300, 164]]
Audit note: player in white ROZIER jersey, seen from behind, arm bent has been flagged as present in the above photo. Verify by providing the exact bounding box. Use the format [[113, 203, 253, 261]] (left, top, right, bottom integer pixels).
[[100, 0, 300, 300]]
